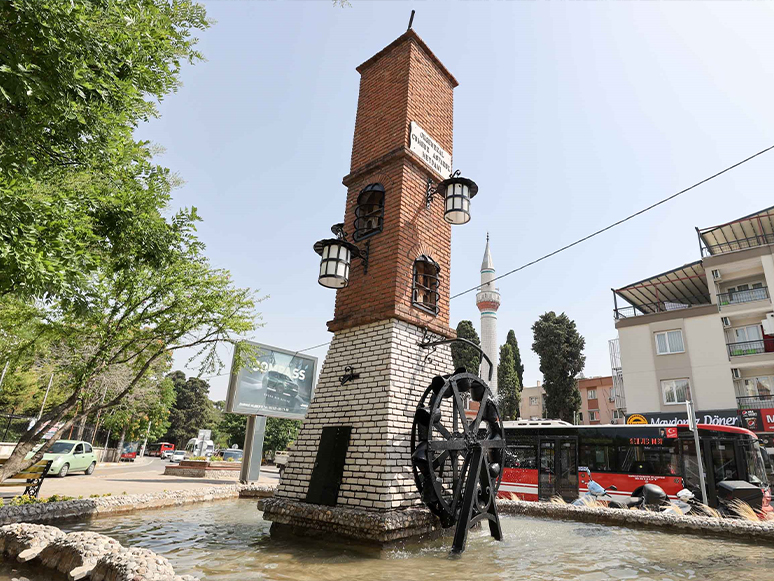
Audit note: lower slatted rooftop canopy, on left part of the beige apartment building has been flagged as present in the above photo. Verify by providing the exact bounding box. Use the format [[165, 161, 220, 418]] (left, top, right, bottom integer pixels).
[[613, 260, 712, 319]]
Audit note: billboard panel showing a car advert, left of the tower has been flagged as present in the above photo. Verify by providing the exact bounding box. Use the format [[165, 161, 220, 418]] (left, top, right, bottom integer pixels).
[[226, 341, 317, 420]]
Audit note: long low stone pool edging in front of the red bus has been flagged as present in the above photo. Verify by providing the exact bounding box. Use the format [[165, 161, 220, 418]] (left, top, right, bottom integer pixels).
[[497, 500, 774, 543]]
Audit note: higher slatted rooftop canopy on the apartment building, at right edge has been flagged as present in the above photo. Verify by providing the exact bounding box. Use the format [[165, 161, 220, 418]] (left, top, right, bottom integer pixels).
[[696, 206, 774, 256]]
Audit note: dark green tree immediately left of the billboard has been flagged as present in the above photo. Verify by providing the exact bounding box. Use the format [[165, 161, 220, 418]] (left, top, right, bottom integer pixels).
[[164, 371, 212, 448]]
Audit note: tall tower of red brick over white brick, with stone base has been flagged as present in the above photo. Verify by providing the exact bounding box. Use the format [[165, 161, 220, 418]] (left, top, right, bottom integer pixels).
[[262, 29, 464, 541]]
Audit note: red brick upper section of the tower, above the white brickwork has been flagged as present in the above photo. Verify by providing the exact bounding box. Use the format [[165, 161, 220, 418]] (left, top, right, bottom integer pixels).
[[328, 31, 457, 337]]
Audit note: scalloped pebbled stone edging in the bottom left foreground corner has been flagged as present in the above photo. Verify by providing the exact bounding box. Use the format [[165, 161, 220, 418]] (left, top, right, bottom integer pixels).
[[0, 523, 197, 581]]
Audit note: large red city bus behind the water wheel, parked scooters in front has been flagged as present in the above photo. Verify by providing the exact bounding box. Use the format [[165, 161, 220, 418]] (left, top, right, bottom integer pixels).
[[499, 420, 772, 511]]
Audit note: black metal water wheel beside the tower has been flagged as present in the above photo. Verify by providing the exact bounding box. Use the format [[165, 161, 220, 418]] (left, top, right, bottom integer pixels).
[[411, 369, 505, 552]]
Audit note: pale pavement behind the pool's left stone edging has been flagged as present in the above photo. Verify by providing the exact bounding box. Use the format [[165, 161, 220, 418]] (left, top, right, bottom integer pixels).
[[2, 457, 279, 499]]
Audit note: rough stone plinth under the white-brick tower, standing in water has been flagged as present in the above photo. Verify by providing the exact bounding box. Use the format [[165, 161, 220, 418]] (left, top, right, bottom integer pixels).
[[258, 497, 441, 544]]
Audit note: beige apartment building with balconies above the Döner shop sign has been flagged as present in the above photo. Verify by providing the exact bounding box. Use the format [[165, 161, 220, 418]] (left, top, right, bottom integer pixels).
[[611, 207, 774, 445]]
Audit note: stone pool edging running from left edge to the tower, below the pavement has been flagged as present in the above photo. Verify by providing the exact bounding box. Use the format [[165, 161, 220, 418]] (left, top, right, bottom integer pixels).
[[0, 484, 274, 525]]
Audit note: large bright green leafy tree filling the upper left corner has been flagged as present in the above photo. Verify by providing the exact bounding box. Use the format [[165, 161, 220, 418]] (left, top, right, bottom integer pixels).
[[0, 0, 208, 308]]
